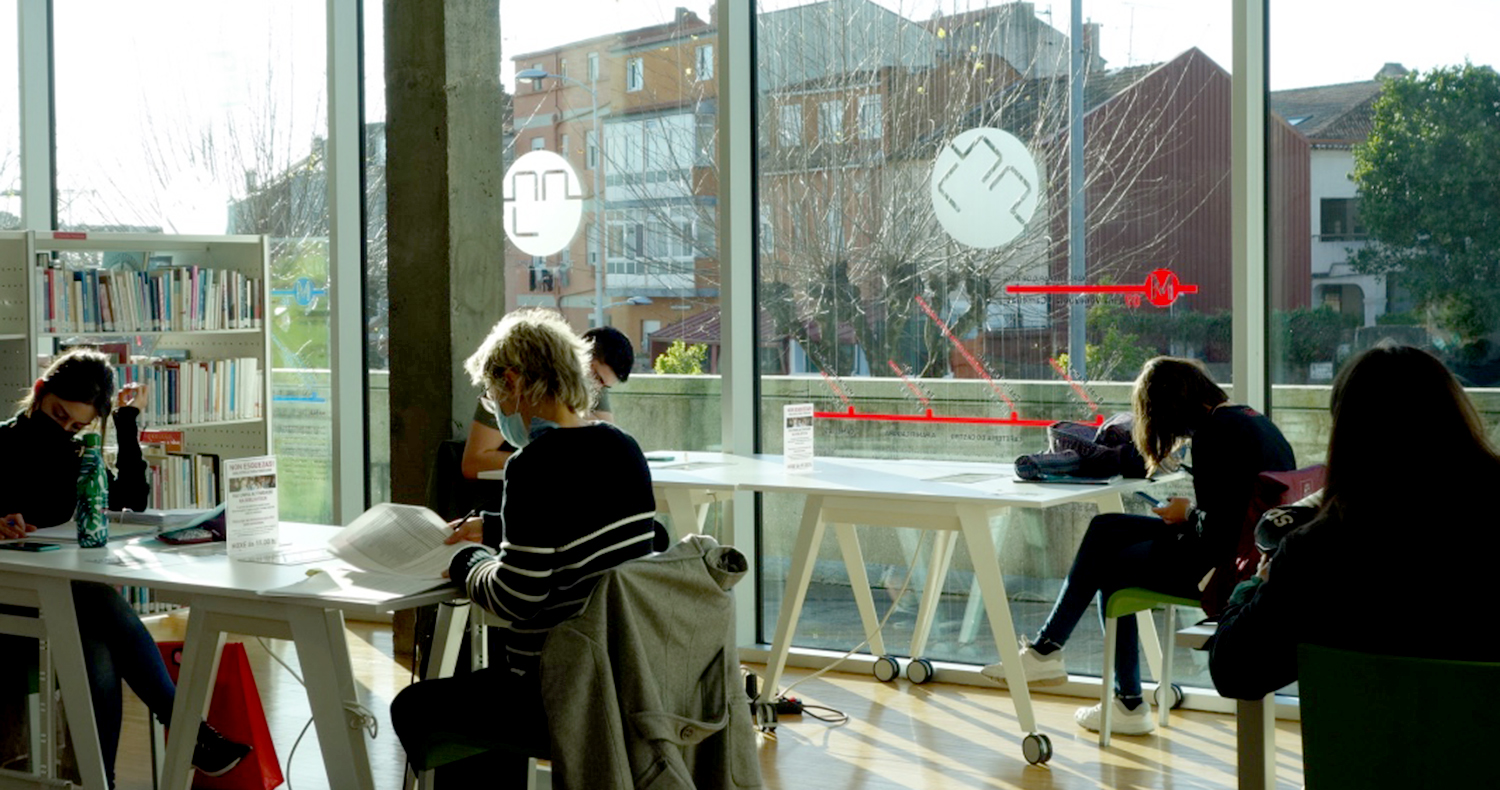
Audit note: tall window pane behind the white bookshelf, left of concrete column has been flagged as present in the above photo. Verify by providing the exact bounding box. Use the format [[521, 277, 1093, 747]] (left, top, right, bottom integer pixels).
[[55, 0, 332, 523]]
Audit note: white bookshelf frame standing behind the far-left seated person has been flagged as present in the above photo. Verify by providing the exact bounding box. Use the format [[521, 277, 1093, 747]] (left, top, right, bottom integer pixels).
[[0, 231, 272, 496]]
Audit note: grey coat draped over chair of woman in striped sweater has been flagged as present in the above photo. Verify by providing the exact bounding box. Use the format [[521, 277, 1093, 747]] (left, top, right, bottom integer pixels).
[[542, 535, 761, 790]]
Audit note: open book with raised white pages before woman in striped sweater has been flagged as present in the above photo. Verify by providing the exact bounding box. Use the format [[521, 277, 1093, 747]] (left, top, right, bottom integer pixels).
[[329, 502, 474, 579]]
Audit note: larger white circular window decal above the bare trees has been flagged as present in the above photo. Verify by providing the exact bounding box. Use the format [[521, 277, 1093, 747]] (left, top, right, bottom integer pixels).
[[932, 129, 1041, 249]]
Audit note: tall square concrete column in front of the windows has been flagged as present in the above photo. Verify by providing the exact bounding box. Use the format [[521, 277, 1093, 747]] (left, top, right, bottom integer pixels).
[[384, 0, 506, 502]]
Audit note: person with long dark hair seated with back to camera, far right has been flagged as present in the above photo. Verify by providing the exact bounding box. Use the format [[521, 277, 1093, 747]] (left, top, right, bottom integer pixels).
[[1208, 343, 1500, 700]]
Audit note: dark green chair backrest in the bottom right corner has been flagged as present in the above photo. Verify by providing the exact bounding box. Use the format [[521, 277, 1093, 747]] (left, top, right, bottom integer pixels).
[[1298, 645, 1500, 790]]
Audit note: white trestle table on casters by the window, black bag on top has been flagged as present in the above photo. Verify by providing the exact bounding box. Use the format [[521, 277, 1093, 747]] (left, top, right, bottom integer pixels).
[[651, 453, 1155, 762]]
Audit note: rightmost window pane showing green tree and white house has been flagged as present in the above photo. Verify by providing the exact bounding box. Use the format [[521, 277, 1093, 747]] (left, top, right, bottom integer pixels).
[[1268, 0, 1500, 463]]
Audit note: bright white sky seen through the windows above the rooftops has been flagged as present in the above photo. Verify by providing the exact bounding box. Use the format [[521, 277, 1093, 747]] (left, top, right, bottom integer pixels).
[[0, 0, 1500, 232]]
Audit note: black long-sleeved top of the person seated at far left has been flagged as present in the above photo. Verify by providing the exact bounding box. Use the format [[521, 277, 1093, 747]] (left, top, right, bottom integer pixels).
[[0, 406, 150, 528]]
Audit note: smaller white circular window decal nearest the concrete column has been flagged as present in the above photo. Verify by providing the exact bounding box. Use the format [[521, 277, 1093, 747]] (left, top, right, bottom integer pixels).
[[501, 151, 584, 255]]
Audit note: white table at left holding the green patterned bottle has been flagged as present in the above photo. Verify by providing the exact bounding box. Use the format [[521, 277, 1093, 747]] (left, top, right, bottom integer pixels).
[[0, 523, 453, 790]]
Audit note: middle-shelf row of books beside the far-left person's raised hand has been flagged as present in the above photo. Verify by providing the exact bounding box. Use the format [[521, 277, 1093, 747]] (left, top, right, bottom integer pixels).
[[116, 357, 266, 426]]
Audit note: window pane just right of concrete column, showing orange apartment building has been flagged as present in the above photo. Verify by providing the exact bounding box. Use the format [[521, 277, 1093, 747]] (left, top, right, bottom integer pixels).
[[495, 0, 722, 530]]
